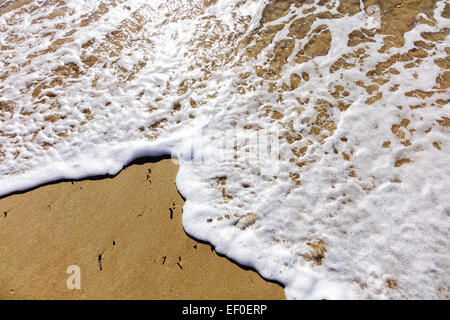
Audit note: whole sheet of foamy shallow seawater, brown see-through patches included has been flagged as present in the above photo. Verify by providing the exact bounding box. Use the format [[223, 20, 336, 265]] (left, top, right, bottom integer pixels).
[[0, 0, 450, 299]]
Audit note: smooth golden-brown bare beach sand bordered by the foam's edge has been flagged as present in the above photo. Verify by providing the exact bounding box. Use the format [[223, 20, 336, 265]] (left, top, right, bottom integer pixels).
[[0, 159, 284, 299]]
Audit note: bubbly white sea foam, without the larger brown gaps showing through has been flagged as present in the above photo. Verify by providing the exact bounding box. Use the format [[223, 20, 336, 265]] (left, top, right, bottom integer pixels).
[[0, 0, 450, 299]]
